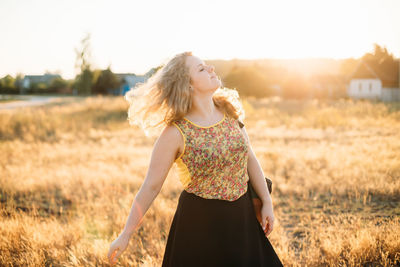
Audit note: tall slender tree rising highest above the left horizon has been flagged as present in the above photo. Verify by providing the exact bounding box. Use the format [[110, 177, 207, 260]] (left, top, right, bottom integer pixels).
[[74, 33, 94, 95]]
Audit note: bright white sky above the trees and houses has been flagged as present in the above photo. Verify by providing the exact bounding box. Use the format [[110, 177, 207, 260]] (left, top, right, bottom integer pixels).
[[0, 0, 400, 79]]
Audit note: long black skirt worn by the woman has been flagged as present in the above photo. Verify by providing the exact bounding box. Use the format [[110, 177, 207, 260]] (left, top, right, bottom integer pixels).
[[162, 184, 283, 267]]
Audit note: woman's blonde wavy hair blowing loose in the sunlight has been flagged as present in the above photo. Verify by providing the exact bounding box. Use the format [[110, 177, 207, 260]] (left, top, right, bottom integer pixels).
[[124, 52, 245, 136]]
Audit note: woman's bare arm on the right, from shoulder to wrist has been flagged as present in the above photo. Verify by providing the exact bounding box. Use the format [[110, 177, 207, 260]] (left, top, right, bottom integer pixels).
[[241, 126, 272, 203]]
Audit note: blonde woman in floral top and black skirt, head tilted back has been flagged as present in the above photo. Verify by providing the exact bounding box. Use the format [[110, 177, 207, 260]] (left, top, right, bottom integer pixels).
[[108, 52, 282, 267]]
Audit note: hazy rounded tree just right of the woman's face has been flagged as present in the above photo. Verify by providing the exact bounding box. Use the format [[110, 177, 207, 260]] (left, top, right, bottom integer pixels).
[[223, 65, 274, 97]]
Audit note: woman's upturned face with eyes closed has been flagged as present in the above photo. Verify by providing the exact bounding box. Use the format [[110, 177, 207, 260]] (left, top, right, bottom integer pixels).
[[186, 56, 221, 92]]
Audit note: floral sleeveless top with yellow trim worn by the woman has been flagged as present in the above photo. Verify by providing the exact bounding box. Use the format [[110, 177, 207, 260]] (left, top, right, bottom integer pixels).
[[173, 113, 249, 201]]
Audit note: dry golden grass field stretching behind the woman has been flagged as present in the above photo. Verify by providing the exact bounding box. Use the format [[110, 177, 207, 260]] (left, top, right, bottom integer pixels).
[[0, 97, 400, 266]]
